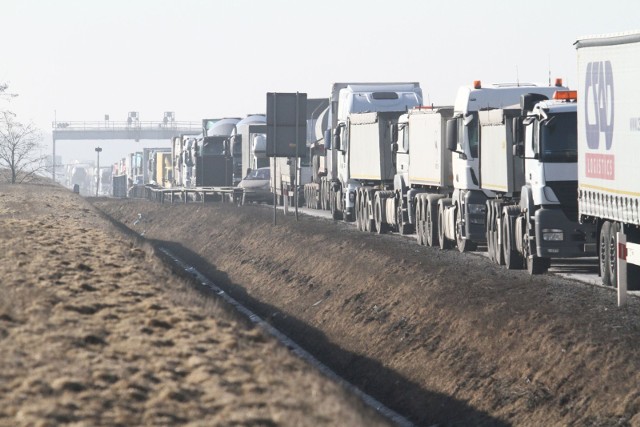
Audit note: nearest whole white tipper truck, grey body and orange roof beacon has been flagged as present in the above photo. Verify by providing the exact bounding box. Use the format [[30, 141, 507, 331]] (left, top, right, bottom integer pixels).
[[478, 91, 596, 274]]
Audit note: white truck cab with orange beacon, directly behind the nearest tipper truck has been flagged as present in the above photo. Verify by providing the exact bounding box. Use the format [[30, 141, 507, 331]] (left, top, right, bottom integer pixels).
[[438, 81, 566, 252]]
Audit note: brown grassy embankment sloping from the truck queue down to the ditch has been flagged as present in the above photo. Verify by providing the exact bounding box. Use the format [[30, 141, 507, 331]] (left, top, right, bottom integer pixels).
[[95, 200, 640, 425]]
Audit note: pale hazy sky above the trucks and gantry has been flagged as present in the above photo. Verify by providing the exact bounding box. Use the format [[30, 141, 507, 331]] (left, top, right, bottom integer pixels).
[[0, 0, 640, 166]]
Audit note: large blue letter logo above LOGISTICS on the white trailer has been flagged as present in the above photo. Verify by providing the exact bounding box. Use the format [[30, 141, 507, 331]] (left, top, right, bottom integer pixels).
[[584, 61, 613, 150]]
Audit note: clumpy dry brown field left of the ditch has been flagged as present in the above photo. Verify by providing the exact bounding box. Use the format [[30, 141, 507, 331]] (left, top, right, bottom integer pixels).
[[0, 185, 388, 427]]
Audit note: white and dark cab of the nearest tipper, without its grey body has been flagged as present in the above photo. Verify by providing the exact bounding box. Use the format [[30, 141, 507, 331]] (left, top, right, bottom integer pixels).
[[514, 91, 596, 271]]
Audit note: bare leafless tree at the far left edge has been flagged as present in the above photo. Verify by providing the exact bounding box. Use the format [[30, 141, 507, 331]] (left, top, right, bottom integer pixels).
[[0, 111, 46, 184]]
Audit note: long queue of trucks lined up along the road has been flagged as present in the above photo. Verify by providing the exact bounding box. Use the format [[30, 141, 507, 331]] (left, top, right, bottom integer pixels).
[[119, 32, 640, 287]]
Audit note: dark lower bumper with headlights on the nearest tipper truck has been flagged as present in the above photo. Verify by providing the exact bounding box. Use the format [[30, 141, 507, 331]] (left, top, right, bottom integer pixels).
[[535, 207, 596, 258]]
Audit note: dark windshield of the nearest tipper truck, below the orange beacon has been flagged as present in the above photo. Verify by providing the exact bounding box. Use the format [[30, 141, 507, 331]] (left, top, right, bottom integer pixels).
[[540, 113, 578, 163]]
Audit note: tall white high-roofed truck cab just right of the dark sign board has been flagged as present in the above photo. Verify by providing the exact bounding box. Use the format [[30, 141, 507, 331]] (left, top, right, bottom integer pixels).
[[304, 82, 422, 220]]
